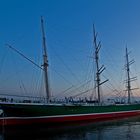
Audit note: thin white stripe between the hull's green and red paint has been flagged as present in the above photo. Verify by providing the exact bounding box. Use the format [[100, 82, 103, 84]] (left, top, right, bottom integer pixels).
[[0, 110, 140, 120]]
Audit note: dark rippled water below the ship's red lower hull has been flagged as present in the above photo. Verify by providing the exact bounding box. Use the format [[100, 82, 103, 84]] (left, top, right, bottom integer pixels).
[[0, 117, 140, 140]]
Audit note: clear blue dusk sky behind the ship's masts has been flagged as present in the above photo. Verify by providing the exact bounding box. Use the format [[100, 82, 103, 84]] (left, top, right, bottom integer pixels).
[[0, 0, 140, 100]]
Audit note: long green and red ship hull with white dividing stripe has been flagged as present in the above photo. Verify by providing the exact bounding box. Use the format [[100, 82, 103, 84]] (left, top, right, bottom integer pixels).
[[0, 104, 140, 126]]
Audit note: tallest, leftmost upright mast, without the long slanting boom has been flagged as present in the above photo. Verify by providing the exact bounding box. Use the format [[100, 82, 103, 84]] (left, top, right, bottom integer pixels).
[[41, 17, 50, 103]]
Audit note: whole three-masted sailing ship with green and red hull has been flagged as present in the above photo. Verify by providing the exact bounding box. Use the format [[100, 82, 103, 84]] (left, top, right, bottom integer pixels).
[[0, 17, 140, 126]]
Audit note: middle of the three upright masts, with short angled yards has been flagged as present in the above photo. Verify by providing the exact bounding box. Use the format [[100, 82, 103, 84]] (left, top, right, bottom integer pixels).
[[93, 25, 108, 104]]
